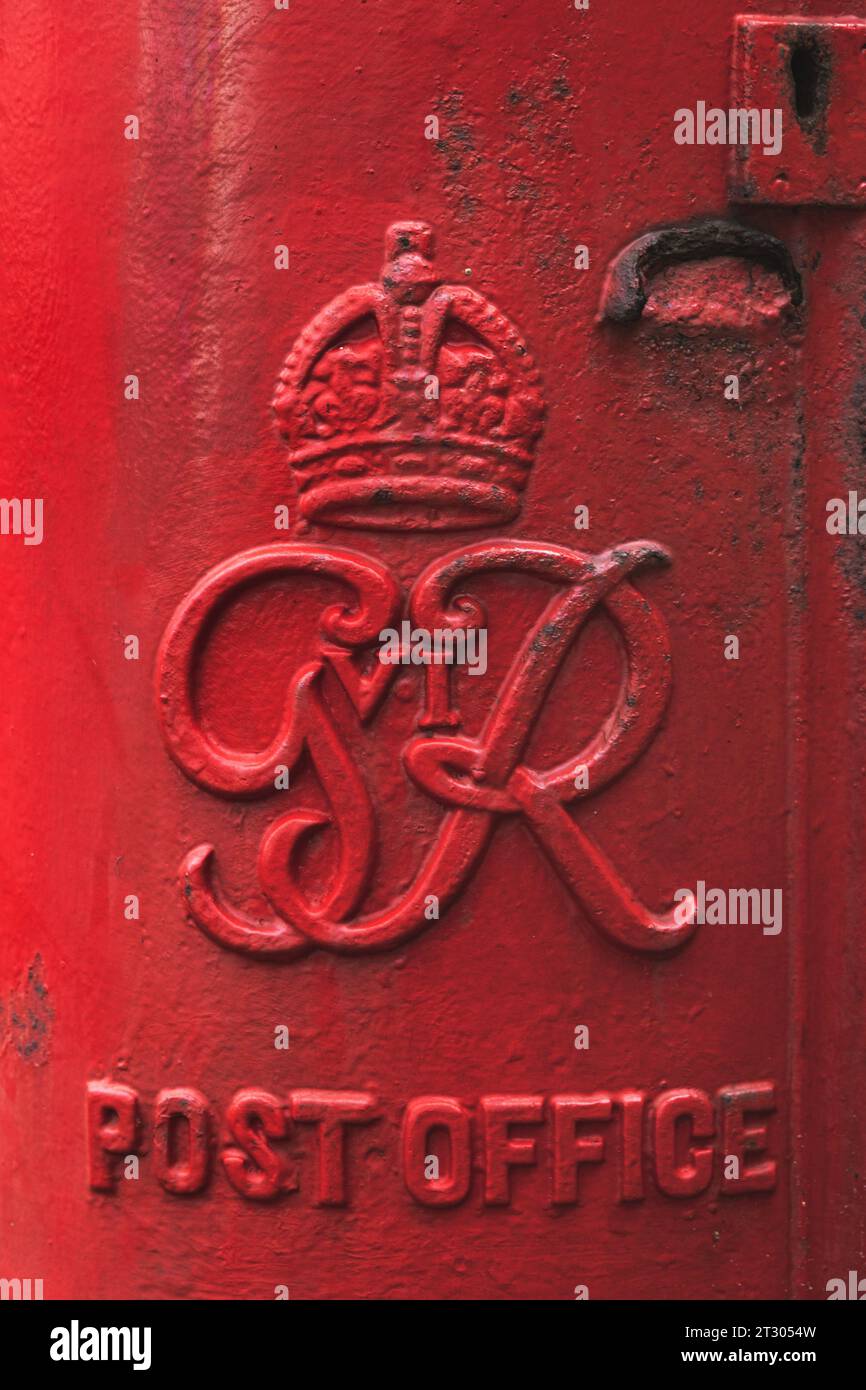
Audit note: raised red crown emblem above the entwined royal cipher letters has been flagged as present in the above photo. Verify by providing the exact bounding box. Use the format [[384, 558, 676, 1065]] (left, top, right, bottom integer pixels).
[[274, 222, 544, 530]]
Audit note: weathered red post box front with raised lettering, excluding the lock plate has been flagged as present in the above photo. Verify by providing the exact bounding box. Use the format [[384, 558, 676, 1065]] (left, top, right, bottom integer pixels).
[[0, 0, 866, 1300]]
